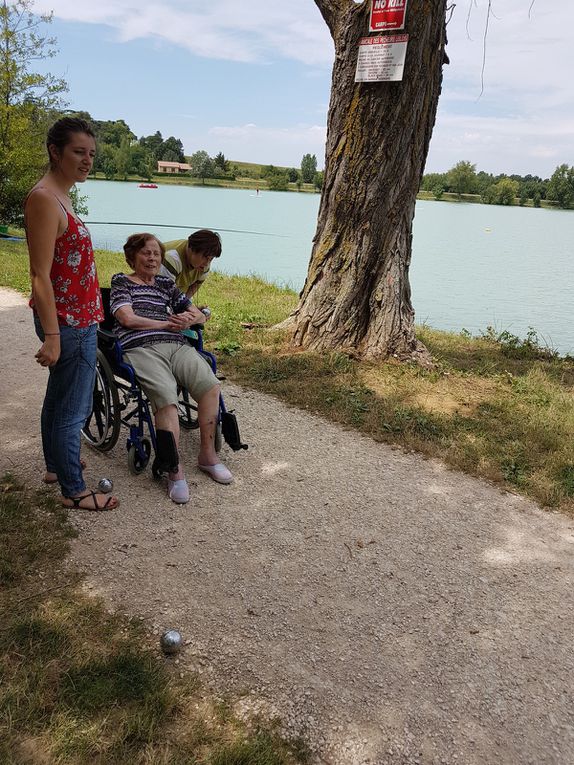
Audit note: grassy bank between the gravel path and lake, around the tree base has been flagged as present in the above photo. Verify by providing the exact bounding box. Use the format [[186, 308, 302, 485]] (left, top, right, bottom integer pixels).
[[0, 242, 574, 513]]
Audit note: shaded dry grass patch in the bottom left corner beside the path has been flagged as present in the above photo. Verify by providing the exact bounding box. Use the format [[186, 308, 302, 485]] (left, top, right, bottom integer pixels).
[[0, 475, 307, 765]]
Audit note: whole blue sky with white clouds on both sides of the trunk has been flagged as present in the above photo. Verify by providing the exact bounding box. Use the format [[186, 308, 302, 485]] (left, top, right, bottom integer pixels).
[[34, 0, 574, 178]]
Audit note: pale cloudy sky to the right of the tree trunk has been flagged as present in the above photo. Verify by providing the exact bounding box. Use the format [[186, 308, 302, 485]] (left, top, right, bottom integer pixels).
[[427, 0, 574, 176]]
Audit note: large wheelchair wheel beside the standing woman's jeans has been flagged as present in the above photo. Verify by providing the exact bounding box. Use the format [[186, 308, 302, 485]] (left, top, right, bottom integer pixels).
[[82, 348, 122, 452]]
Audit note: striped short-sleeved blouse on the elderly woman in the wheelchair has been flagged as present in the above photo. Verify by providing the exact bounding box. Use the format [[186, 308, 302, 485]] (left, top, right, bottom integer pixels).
[[110, 274, 191, 351]]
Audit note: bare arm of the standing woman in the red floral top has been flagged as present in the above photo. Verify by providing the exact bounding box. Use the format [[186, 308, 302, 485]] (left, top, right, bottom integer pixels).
[[26, 189, 67, 366]]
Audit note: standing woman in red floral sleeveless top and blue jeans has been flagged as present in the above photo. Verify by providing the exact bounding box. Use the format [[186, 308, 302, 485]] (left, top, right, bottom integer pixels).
[[24, 117, 119, 510]]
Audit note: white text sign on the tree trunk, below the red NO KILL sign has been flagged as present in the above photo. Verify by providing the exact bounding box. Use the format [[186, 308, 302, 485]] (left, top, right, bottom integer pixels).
[[355, 35, 409, 82]]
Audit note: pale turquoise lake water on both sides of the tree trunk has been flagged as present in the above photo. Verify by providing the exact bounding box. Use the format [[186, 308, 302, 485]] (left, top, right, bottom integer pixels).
[[81, 181, 574, 353]]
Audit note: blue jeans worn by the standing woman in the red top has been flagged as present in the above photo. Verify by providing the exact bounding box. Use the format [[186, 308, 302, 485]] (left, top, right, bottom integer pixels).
[[34, 314, 98, 497]]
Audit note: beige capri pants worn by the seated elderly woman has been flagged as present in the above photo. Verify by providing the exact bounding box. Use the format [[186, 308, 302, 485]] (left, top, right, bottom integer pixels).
[[124, 343, 219, 414]]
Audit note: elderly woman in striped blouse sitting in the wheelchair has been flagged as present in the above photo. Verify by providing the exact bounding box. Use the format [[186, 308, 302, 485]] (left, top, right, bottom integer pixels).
[[110, 233, 233, 503]]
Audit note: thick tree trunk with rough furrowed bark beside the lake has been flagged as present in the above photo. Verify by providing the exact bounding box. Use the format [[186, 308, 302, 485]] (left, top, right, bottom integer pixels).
[[292, 0, 446, 361]]
